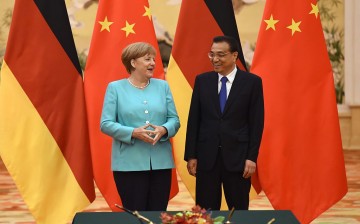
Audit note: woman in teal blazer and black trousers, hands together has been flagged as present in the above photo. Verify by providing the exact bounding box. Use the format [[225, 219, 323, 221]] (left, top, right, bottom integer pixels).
[[100, 42, 180, 211]]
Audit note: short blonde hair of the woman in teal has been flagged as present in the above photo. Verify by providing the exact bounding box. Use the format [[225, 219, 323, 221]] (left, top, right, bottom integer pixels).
[[121, 42, 156, 74]]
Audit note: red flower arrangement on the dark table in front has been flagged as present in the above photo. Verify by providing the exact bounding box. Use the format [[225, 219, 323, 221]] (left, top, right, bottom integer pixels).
[[160, 205, 225, 224]]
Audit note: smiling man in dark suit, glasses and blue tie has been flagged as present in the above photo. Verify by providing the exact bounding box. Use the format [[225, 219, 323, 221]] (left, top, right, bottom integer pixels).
[[184, 36, 264, 210]]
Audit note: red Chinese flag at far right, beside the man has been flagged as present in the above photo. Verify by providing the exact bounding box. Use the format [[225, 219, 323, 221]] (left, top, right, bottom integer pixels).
[[251, 0, 347, 223]]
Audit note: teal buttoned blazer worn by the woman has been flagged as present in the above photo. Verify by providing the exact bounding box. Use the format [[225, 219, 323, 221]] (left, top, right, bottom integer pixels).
[[100, 78, 180, 171]]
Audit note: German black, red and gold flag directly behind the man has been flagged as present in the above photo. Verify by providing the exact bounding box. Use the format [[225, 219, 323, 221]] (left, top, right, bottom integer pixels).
[[166, 0, 249, 209]]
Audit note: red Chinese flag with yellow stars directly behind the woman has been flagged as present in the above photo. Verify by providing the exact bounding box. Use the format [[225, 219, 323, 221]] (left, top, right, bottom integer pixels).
[[85, 0, 178, 210]]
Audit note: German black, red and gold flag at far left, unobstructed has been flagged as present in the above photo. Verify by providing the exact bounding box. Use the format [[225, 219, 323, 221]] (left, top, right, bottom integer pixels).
[[0, 0, 95, 223]]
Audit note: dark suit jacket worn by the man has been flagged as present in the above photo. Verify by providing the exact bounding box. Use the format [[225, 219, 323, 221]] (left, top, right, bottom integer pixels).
[[184, 69, 264, 172]]
